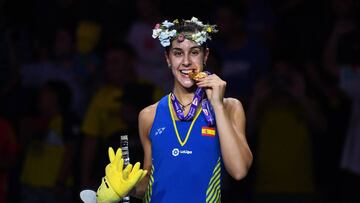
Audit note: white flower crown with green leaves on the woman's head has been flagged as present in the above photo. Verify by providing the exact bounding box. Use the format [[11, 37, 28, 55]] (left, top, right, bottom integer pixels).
[[152, 17, 218, 47]]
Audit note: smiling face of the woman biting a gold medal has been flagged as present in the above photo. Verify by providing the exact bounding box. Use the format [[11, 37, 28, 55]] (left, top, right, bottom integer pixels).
[[165, 39, 209, 88]]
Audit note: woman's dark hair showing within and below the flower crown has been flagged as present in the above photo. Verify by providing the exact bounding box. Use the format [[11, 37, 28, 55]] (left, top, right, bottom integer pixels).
[[165, 20, 207, 53]]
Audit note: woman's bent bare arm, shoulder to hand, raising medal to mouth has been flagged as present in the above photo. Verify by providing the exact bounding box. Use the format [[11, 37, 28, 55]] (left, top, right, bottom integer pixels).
[[197, 74, 253, 180]]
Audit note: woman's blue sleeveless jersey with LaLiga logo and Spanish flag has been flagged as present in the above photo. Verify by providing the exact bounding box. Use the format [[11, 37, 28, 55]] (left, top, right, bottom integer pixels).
[[144, 95, 223, 203]]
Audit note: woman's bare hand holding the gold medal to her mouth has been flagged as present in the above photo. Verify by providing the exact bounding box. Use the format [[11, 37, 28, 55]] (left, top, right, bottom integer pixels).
[[196, 74, 226, 107]]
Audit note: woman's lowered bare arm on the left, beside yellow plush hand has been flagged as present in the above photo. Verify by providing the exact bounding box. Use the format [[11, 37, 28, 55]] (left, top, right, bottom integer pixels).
[[130, 103, 157, 199]]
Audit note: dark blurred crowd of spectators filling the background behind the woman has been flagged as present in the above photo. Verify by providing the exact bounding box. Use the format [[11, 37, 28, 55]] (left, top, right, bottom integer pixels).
[[0, 0, 360, 203]]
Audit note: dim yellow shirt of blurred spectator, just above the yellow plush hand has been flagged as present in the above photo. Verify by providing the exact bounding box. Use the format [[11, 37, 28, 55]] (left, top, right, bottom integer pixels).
[[82, 85, 126, 137]]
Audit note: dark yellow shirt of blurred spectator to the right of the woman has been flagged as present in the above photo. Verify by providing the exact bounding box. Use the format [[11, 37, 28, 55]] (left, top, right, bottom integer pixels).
[[256, 105, 314, 193]]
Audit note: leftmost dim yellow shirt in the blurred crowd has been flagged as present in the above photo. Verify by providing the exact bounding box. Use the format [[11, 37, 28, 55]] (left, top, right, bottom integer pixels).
[[21, 117, 64, 187]]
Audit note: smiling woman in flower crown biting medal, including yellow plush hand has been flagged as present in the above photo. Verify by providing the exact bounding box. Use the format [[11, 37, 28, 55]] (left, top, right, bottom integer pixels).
[[97, 17, 252, 203]]
